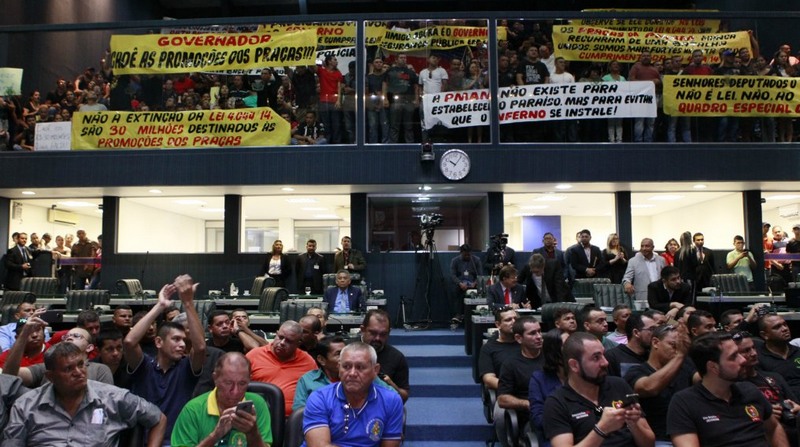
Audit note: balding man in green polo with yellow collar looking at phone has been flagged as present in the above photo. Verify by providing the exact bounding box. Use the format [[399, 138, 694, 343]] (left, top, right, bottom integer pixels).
[[171, 352, 272, 447]]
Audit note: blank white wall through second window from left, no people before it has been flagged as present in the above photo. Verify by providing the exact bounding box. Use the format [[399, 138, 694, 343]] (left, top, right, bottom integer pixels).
[[117, 199, 206, 253]]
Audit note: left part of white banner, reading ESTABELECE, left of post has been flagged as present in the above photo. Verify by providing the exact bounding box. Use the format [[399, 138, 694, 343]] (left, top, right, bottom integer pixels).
[[422, 89, 490, 129]]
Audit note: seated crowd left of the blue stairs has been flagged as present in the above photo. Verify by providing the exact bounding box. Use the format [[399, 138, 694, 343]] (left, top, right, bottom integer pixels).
[[0, 275, 409, 446]]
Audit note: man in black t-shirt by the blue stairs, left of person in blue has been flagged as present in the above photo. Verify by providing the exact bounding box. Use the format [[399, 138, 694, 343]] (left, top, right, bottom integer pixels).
[[497, 316, 544, 421]]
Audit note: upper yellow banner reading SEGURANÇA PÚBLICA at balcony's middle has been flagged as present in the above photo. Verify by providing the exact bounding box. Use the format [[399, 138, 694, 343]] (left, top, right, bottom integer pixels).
[[379, 26, 494, 53]]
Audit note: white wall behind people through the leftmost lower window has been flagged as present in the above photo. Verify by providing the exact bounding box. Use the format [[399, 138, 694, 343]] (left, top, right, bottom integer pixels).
[[8, 200, 103, 247]]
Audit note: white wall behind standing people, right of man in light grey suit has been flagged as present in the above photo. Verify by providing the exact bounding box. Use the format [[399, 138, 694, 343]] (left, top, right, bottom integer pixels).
[[644, 193, 744, 250]]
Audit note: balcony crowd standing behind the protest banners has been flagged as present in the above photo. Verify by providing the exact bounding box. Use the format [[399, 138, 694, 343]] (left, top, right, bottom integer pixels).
[[0, 20, 797, 150]]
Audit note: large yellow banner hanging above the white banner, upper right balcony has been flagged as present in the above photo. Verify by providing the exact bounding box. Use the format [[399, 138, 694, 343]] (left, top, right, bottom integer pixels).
[[553, 25, 752, 64]]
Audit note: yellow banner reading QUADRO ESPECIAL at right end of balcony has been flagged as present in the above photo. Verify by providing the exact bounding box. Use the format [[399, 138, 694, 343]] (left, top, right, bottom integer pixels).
[[664, 76, 800, 118]]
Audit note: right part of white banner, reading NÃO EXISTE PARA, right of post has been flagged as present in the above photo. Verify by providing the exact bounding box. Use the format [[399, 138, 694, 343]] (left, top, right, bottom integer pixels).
[[498, 81, 657, 124]]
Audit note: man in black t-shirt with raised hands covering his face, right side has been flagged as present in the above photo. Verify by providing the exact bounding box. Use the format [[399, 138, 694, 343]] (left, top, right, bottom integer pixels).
[[625, 325, 699, 442]]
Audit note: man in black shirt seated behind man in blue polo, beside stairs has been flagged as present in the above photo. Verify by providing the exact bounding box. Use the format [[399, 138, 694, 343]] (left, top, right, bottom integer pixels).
[[361, 309, 411, 402]]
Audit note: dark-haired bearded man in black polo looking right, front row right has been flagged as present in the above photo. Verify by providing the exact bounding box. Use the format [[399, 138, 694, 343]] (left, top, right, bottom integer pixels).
[[667, 333, 789, 447]]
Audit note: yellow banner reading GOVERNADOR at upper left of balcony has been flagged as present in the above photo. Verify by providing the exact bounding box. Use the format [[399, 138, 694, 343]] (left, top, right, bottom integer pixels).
[[110, 29, 317, 74]]
